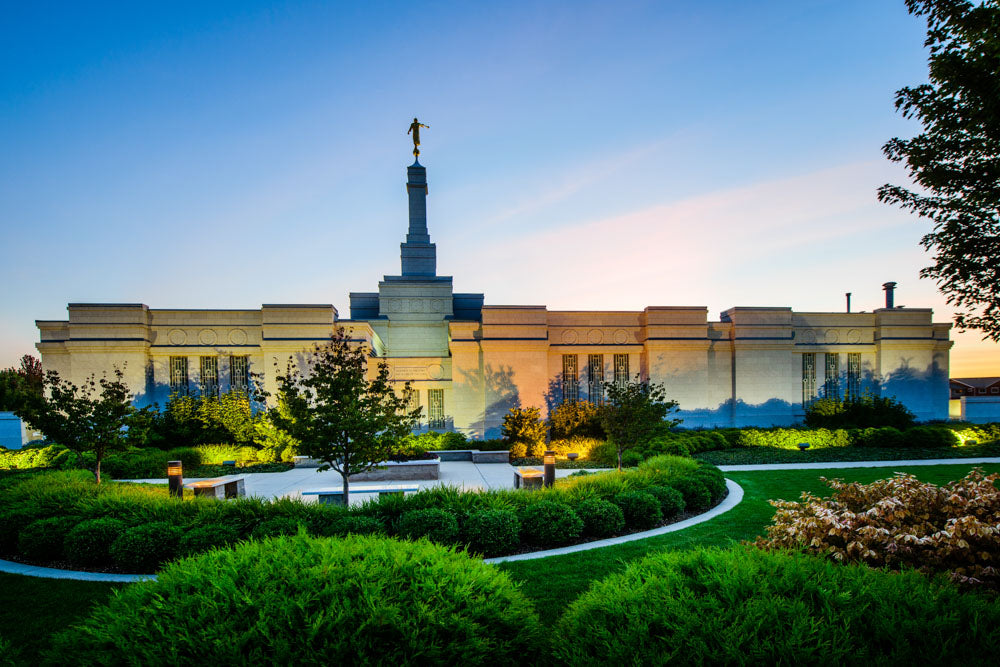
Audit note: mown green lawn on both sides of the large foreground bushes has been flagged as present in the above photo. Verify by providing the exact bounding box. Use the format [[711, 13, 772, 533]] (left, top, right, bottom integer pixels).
[[0, 464, 1000, 665]]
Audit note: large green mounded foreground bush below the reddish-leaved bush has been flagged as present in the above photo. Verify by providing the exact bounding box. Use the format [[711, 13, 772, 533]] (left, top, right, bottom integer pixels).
[[553, 548, 1000, 665]]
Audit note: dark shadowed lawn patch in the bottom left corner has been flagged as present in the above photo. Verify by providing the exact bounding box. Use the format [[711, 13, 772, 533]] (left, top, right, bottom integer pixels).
[[0, 572, 123, 665]]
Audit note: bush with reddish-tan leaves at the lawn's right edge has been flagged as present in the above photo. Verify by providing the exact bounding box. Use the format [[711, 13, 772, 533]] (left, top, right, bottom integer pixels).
[[756, 468, 1000, 591]]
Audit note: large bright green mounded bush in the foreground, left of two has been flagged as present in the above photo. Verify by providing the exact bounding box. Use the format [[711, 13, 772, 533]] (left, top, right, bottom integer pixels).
[[50, 535, 543, 665]]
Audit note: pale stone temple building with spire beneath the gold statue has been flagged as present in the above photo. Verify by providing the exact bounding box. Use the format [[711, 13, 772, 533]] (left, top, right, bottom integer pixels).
[[36, 157, 952, 438]]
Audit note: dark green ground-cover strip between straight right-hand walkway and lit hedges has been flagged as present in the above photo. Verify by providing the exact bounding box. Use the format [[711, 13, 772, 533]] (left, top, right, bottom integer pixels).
[[695, 441, 1000, 466]]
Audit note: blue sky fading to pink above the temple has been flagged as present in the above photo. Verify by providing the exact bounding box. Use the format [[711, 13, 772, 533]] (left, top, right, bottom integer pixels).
[[0, 0, 1000, 375]]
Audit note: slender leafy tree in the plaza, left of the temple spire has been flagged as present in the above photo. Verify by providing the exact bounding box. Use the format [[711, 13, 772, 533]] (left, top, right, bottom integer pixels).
[[269, 327, 420, 504]]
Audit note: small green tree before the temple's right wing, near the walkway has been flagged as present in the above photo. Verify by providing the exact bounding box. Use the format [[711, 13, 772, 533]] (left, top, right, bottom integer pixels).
[[601, 375, 681, 470]]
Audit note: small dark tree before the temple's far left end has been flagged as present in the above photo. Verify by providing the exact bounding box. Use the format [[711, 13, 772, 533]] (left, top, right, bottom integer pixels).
[[17, 367, 136, 484]]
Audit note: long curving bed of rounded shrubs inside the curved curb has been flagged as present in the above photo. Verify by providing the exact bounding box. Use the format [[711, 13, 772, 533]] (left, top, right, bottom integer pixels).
[[0, 456, 726, 572]]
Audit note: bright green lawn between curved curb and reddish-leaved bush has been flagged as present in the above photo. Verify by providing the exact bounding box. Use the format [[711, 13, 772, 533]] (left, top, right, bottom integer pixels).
[[498, 464, 1000, 622]]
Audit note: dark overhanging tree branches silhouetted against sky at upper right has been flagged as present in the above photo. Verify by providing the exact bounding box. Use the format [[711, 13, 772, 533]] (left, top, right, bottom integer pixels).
[[878, 0, 1000, 340]]
